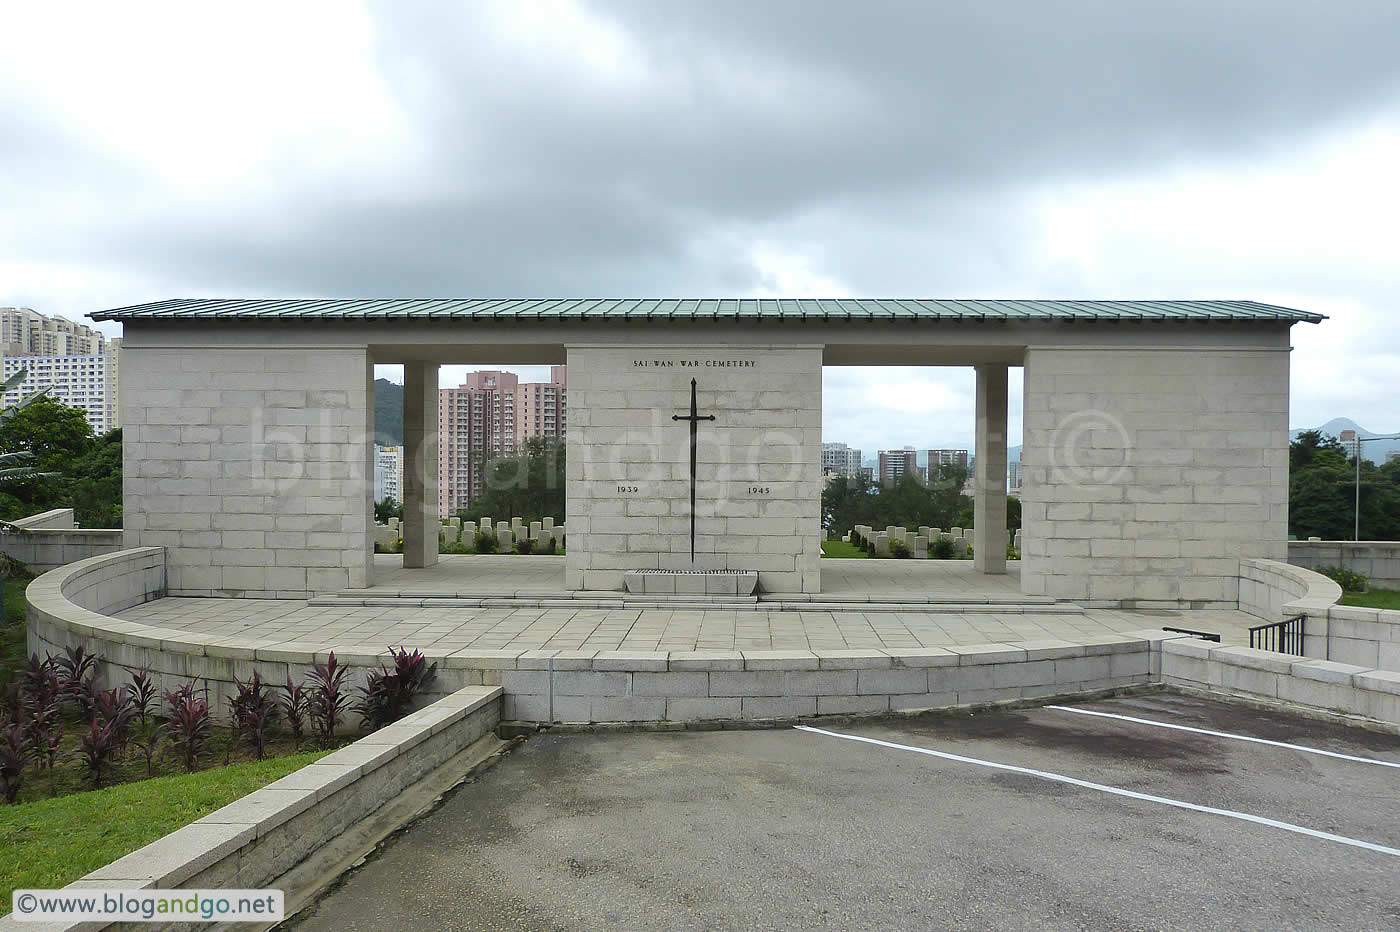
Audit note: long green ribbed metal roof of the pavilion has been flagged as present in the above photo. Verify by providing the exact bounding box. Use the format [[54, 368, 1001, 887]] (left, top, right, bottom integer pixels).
[[90, 298, 1324, 323]]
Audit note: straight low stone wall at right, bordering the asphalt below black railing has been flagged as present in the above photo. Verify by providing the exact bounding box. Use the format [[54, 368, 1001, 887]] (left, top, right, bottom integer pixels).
[[1161, 638, 1400, 726]]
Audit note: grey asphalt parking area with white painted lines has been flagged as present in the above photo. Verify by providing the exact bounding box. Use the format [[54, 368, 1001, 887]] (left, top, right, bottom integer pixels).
[[290, 694, 1400, 932]]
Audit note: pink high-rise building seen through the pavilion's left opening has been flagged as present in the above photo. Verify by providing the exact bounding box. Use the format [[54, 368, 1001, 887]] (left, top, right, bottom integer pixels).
[[438, 365, 567, 518]]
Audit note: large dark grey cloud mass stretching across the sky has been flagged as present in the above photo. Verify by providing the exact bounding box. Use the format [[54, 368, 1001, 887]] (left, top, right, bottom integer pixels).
[[7, 0, 1400, 298]]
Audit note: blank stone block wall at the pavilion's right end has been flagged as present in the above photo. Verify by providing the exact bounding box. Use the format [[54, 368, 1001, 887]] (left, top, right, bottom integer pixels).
[[1021, 347, 1288, 607]]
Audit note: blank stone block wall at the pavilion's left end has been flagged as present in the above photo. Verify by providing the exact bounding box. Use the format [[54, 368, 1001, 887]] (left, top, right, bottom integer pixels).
[[120, 346, 374, 598]]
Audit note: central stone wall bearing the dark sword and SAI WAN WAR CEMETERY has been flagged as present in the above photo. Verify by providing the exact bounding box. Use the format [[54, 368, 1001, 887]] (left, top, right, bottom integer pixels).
[[566, 346, 822, 592]]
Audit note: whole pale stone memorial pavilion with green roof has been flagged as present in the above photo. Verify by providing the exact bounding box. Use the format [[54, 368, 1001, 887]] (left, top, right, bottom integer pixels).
[[101, 293, 1322, 607]]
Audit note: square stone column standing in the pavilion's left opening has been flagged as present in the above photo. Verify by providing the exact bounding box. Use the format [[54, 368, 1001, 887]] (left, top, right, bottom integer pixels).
[[403, 362, 440, 570]]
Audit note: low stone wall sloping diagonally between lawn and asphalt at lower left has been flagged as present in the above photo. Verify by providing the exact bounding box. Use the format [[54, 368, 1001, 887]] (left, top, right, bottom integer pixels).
[[0, 687, 501, 929]]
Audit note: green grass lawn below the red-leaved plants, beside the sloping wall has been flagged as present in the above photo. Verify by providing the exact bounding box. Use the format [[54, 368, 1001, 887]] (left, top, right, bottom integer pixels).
[[0, 751, 329, 914]]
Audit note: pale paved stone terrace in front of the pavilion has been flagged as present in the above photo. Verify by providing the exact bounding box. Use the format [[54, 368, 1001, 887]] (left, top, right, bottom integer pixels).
[[119, 557, 1259, 654]]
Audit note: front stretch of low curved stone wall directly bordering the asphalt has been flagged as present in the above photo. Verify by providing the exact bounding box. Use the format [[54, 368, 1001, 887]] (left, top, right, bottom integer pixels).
[[486, 631, 1170, 722]]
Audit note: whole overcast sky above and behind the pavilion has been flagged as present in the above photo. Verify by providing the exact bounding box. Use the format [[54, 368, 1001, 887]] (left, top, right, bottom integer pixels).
[[0, 0, 1400, 452]]
